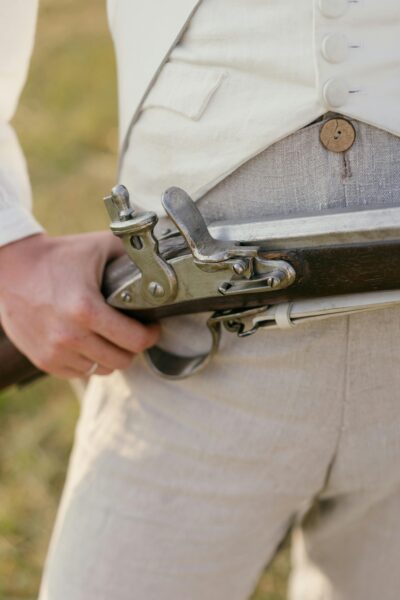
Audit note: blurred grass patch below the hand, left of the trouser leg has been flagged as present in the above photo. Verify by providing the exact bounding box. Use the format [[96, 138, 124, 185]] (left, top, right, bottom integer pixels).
[[0, 378, 77, 600]]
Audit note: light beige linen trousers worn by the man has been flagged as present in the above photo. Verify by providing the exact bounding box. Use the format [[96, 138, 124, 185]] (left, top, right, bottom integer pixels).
[[40, 117, 400, 600]]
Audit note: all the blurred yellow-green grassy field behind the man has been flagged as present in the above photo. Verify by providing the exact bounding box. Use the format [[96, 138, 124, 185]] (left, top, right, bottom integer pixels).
[[0, 0, 288, 600]]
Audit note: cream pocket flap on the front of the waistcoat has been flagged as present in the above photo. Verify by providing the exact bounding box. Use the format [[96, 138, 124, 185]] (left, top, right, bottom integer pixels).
[[142, 62, 227, 121]]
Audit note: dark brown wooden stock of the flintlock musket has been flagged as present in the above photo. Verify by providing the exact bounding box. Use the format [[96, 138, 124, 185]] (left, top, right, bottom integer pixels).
[[0, 238, 400, 390]]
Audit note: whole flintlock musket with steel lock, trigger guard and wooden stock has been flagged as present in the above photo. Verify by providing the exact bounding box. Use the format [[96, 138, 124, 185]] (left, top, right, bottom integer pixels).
[[0, 186, 400, 389]]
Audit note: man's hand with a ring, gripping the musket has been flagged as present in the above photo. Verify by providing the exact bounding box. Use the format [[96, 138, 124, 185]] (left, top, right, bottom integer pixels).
[[0, 232, 159, 378]]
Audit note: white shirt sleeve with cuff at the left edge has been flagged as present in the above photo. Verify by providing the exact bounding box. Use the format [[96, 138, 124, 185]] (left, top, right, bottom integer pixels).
[[0, 0, 43, 245]]
